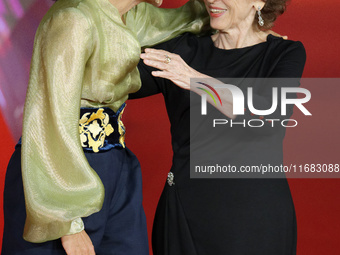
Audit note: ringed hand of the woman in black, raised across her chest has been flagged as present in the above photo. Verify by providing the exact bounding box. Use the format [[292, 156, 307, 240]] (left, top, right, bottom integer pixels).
[[141, 48, 208, 90]]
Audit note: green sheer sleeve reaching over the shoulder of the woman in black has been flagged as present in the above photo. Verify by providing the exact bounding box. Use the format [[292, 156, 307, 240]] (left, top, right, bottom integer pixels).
[[126, 0, 210, 47]]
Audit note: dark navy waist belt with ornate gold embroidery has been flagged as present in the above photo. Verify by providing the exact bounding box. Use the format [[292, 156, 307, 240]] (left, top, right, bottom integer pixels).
[[79, 103, 126, 152]]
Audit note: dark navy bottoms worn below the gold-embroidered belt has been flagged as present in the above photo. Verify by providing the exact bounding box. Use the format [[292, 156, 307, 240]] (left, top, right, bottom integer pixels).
[[1, 145, 149, 255]]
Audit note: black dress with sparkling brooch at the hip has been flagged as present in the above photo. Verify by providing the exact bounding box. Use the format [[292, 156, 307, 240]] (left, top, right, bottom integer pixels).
[[130, 34, 306, 255]]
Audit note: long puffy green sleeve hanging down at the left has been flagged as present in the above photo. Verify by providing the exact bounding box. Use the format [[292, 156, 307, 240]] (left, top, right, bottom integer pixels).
[[22, 8, 104, 242]]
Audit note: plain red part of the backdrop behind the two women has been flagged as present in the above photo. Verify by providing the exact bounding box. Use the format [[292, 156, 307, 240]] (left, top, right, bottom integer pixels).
[[0, 0, 340, 255]]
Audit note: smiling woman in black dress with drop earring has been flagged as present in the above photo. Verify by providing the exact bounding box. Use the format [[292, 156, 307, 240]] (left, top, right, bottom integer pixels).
[[130, 0, 306, 255]]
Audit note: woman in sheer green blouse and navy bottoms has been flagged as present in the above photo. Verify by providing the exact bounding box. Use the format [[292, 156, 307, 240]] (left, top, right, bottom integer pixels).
[[2, 0, 208, 255]]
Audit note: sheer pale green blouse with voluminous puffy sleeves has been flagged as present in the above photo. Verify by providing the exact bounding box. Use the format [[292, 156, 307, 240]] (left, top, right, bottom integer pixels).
[[22, 0, 209, 242]]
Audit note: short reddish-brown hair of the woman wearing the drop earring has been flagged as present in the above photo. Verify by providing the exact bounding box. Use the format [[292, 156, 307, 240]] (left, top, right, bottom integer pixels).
[[254, 0, 288, 30]]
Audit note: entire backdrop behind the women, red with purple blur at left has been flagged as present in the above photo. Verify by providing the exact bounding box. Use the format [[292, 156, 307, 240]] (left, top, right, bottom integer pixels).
[[0, 0, 340, 255]]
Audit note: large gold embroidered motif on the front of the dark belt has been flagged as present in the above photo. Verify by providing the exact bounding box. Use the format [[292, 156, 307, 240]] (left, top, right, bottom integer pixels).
[[79, 108, 114, 152]]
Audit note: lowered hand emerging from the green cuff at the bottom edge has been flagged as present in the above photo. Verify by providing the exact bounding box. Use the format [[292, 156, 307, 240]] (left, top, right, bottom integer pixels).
[[61, 230, 96, 255]]
